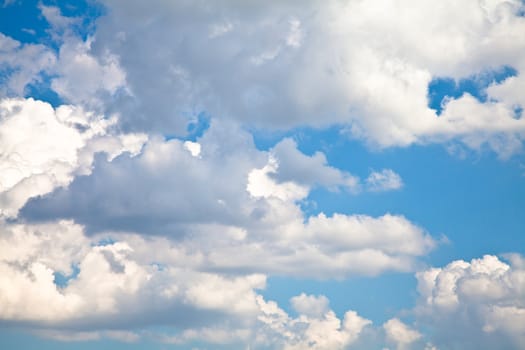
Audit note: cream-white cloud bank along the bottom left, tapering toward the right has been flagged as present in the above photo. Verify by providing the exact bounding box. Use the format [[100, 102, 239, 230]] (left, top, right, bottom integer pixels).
[[0, 221, 370, 349]]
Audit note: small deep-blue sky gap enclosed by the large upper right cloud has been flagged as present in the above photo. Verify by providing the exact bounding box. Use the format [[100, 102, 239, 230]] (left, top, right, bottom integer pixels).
[[428, 66, 518, 115]]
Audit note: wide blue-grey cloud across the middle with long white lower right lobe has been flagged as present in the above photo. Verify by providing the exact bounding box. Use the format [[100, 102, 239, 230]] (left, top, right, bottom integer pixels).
[[22, 123, 435, 278]]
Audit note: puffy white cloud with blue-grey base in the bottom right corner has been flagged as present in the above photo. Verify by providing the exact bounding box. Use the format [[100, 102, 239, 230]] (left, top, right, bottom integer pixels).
[[416, 255, 525, 348]]
